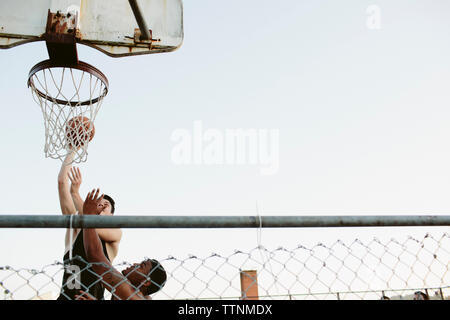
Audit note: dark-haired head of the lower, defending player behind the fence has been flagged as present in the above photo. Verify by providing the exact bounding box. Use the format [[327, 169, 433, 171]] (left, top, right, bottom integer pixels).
[[122, 259, 167, 296]]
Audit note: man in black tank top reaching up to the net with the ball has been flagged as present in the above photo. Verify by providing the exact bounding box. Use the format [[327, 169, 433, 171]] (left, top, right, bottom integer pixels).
[[58, 153, 122, 300]]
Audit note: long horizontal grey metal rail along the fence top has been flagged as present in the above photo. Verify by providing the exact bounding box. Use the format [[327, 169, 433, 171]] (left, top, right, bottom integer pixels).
[[0, 215, 450, 228]]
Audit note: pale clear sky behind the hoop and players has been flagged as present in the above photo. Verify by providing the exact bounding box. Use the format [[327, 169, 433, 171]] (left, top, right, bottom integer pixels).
[[0, 0, 450, 298]]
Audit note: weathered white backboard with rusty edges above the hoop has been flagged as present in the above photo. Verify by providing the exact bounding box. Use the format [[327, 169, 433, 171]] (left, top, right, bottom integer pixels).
[[0, 0, 183, 57]]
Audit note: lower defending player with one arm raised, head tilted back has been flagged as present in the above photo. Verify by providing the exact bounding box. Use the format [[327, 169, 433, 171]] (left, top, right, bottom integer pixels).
[[76, 189, 167, 300]]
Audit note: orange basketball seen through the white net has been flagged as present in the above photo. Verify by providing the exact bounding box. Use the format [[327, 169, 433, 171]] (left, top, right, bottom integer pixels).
[[66, 116, 95, 149]]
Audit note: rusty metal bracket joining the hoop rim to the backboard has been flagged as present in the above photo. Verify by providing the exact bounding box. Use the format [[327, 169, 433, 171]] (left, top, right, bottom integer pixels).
[[44, 10, 78, 63]]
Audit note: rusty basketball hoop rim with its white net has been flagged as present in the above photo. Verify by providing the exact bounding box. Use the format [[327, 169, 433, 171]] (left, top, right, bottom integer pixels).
[[28, 60, 108, 163]]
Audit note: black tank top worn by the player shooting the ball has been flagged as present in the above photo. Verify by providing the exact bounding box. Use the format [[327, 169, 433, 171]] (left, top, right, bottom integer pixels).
[[57, 229, 111, 300]]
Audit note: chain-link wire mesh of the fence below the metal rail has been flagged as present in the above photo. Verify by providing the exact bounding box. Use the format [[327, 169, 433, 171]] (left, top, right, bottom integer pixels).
[[0, 233, 450, 300]]
